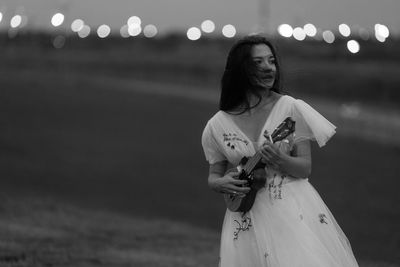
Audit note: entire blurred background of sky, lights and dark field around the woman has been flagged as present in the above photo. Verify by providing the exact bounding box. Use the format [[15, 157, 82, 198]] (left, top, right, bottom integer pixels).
[[0, 0, 400, 267]]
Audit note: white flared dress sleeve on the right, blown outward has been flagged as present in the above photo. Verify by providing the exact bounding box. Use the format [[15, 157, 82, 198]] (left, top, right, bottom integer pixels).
[[292, 99, 336, 147]]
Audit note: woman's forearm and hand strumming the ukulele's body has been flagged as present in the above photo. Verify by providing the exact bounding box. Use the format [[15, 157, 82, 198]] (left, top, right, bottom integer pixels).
[[208, 161, 250, 196]]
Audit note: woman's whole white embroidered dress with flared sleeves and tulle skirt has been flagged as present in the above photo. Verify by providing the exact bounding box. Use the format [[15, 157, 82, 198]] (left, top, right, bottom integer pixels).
[[202, 95, 358, 267]]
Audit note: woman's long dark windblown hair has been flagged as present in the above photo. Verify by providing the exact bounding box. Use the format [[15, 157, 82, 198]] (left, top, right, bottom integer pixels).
[[219, 35, 282, 114]]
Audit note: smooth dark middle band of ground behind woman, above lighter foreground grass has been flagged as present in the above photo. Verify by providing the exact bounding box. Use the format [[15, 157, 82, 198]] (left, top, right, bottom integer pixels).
[[0, 69, 400, 262]]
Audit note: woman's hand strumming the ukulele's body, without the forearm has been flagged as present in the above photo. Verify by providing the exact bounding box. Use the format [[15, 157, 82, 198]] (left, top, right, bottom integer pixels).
[[210, 170, 250, 197]]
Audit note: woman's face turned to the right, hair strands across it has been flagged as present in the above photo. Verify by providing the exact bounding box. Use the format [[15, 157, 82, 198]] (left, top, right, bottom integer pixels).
[[251, 44, 276, 88]]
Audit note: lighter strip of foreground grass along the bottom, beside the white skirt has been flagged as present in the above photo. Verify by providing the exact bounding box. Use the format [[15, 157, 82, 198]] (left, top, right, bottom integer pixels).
[[0, 194, 399, 267]]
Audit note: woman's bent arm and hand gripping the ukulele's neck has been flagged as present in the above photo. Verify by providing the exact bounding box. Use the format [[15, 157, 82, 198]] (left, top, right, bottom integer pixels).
[[261, 140, 311, 178]]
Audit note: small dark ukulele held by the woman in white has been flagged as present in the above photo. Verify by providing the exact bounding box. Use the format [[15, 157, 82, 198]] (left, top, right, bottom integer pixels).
[[224, 117, 295, 212]]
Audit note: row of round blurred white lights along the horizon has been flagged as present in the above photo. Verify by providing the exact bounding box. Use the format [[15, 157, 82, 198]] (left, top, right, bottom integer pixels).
[[0, 9, 390, 53]]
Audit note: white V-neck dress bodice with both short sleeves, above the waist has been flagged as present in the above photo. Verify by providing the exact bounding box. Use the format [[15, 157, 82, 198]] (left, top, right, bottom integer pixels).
[[202, 95, 336, 164]]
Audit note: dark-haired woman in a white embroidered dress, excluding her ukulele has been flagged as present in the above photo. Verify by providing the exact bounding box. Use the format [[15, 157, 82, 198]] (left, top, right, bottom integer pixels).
[[202, 36, 358, 267]]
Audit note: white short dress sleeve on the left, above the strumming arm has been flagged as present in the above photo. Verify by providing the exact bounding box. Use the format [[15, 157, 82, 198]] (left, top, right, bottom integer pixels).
[[201, 122, 226, 164]]
